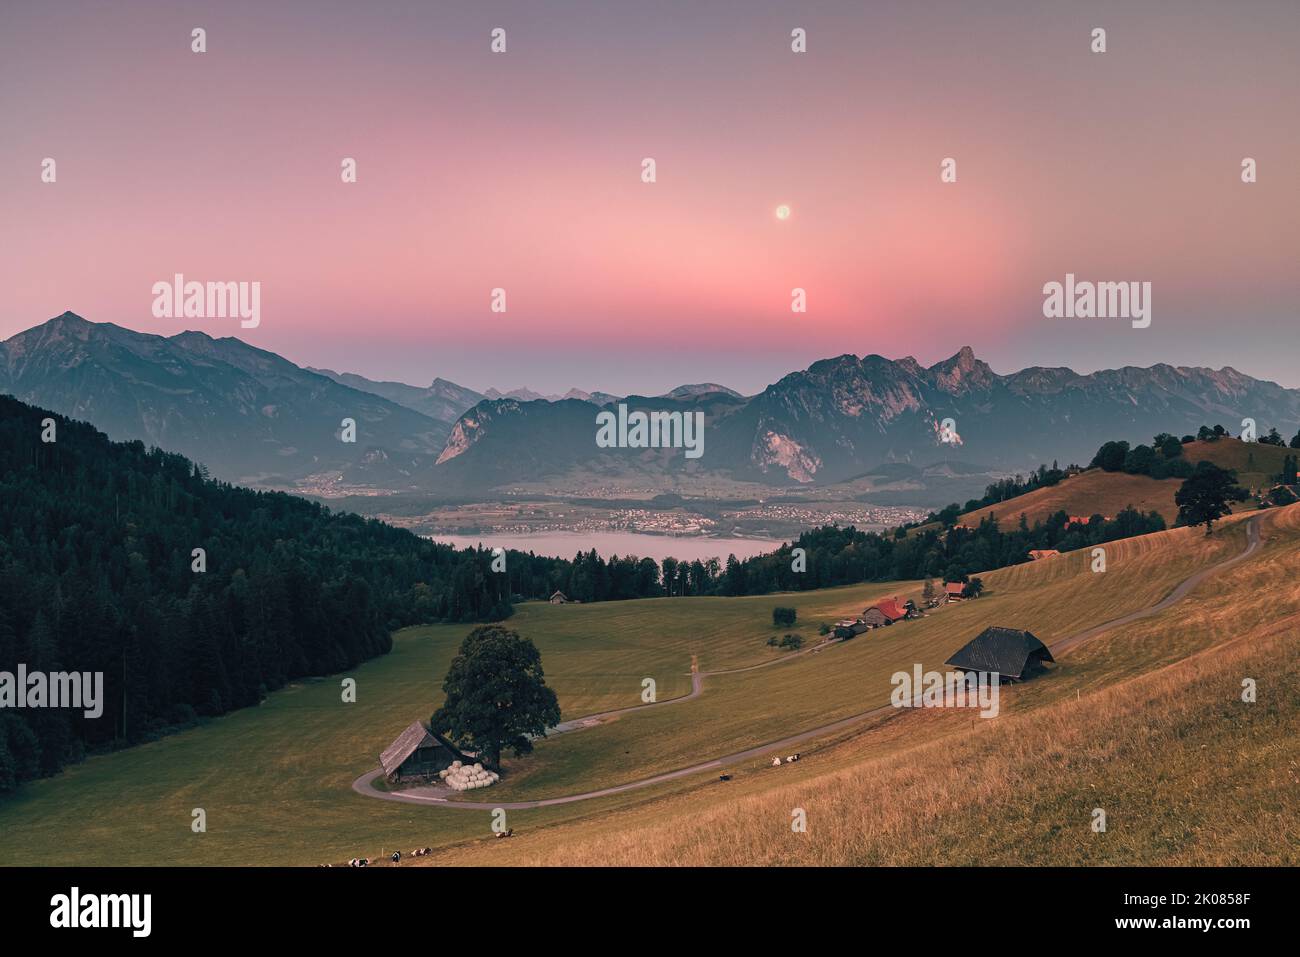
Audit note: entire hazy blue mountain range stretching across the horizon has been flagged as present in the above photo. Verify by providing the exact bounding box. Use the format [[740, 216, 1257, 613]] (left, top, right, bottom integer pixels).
[[0, 312, 1300, 494]]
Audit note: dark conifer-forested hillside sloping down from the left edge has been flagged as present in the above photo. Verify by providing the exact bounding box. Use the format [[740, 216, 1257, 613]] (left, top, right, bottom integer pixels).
[[0, 395, 525, 792]]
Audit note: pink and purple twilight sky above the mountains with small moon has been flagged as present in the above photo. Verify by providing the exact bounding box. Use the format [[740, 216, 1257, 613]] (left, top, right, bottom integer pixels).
[[0, 0, 1300, 394]]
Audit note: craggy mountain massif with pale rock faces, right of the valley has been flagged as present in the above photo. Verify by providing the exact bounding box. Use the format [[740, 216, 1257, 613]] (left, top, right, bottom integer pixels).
[[423, 347, 1300, 484]]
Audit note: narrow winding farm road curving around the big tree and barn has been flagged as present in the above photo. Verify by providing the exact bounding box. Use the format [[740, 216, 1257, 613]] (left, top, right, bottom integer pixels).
[[352, 515, 1261, 811]]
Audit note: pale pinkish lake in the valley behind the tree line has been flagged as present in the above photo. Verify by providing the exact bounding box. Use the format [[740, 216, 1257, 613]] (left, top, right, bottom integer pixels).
[[429, 532, 781, 562]]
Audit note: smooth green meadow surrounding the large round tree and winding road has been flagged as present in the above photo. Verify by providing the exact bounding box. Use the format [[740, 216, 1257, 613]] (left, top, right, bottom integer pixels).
[[0, 521, 1263, 865]]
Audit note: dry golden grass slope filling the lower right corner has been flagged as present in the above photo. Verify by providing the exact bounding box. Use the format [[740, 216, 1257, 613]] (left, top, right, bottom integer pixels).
[[413, 506, 1300, 866]]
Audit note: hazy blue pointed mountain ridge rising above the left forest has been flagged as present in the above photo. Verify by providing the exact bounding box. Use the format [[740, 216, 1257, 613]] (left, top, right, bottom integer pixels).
[[0, 312, 450, 485]]
